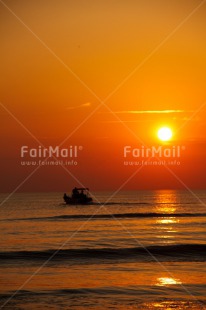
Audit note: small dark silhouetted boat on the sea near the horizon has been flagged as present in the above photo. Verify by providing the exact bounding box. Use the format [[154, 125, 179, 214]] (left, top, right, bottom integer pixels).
[[63, 187, 93, 205]]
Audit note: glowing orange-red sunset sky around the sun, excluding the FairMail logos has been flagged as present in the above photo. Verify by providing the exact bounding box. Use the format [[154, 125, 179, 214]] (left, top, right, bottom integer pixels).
[[0, 0, 206, 192]]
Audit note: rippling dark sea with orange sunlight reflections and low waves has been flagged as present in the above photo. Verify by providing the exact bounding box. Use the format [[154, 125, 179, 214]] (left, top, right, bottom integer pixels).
[[0, 190, 206, 310]]
